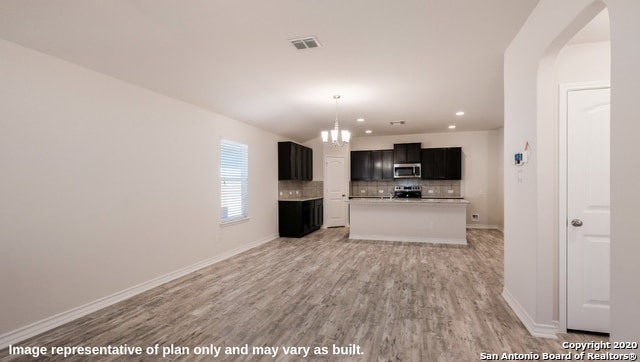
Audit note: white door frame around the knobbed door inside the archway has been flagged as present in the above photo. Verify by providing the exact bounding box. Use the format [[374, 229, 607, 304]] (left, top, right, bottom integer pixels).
[[558, 81, 611, 333]]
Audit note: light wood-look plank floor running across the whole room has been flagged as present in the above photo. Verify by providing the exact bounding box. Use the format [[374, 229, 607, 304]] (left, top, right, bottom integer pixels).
[[0, 228, 608, 362]]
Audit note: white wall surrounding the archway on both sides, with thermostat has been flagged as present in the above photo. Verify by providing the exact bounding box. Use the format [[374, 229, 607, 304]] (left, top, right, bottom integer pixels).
[[503, 0, 640, 341]]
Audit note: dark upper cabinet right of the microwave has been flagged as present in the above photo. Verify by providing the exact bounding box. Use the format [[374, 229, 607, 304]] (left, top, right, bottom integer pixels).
[[422, 147, 462, 180]]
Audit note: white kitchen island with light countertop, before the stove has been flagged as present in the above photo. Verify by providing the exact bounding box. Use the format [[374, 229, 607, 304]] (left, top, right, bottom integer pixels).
[[349, 198, 469, 245]]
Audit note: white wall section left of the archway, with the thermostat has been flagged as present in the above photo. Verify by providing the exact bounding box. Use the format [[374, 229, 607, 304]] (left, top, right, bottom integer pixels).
[[503, 0, 605, 338]]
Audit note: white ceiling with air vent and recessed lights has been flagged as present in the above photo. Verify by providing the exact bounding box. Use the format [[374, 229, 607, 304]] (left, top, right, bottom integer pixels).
[[0, 0, 537, 142]]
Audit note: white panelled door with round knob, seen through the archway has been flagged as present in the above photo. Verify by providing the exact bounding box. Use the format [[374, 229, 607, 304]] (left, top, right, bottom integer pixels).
[[567, 88, 610, 333]]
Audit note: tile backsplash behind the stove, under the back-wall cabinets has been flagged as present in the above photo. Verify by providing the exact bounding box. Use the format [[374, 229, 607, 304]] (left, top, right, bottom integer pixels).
[[350, 180, 462, 198]]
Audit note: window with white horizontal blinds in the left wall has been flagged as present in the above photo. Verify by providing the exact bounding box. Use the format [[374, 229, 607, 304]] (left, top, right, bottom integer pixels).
[[220, 140, 249, 223]]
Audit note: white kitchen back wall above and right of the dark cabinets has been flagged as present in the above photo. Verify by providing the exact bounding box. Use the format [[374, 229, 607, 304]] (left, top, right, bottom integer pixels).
[[351, 129, 503, 228]]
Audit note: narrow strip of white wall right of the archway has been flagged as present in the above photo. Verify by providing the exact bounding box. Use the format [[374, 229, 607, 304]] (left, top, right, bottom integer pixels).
[[605, 0, 640, 341]]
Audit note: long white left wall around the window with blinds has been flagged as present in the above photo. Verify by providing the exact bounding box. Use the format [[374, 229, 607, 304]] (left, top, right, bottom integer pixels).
[[0, 40, 278, 337]]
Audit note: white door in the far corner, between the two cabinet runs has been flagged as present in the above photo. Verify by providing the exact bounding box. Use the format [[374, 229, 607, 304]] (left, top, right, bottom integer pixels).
[[324, 156, 348, 227]]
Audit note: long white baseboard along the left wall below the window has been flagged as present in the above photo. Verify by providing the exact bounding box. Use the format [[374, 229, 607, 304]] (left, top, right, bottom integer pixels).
[[0, 235, 277, 349]]
